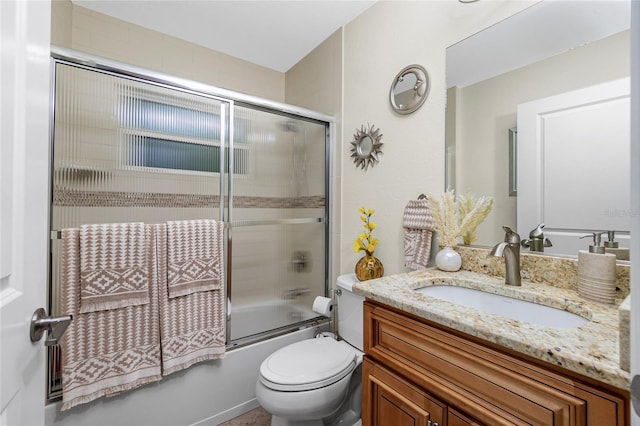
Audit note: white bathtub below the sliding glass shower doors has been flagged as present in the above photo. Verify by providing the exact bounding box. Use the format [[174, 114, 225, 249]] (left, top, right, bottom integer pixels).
[[45, 301, 329, 426]]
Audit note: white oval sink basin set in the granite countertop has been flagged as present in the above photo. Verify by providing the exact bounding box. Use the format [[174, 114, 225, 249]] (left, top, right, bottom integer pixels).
[[416, 285, 589, 328]]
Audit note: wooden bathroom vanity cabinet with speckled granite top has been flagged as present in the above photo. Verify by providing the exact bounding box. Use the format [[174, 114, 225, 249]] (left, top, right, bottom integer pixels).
[[354, 269, 630, 426]]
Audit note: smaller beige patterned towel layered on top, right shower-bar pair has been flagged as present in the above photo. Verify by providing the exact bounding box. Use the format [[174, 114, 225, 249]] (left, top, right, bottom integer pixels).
[[167, 220, 223, 298]]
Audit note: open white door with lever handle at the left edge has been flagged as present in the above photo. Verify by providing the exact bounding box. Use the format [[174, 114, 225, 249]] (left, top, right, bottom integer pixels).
[[0, 0, 51, 425]]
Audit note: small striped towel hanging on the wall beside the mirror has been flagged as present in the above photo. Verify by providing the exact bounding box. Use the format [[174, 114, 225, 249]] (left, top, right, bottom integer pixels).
[[402, 199, 435, 269]]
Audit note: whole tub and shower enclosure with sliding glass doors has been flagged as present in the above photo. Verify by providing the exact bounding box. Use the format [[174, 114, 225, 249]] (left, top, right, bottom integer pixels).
[[46, 48, 331, 425]]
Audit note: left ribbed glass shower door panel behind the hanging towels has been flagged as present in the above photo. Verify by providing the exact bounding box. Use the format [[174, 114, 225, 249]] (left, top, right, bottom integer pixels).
[[49, 62, 231, 397]]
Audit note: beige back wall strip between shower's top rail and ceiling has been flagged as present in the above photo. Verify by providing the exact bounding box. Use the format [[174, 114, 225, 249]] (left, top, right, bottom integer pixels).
[[51, 0, 285, 102]]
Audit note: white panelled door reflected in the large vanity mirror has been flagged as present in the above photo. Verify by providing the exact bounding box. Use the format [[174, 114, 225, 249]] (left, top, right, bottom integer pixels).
[[517, 78, 631, 256]]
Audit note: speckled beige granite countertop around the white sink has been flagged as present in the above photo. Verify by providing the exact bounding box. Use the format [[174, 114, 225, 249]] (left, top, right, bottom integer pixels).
[[353, 269, 630, 389]]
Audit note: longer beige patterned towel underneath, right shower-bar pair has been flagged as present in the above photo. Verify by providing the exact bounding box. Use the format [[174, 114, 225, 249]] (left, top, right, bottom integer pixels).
[[157, 223, 225, 376]]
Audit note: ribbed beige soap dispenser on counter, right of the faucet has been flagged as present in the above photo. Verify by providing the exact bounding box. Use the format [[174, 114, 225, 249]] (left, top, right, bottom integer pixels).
[[578, 232, 616, 304]]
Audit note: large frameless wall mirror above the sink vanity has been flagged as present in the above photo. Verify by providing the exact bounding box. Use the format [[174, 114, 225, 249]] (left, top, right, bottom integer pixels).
[[445, 1, 630, 256]]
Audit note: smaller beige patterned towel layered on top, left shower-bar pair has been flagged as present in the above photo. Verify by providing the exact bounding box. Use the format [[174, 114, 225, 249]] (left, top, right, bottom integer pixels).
[[80, 223, 149, 313]]
